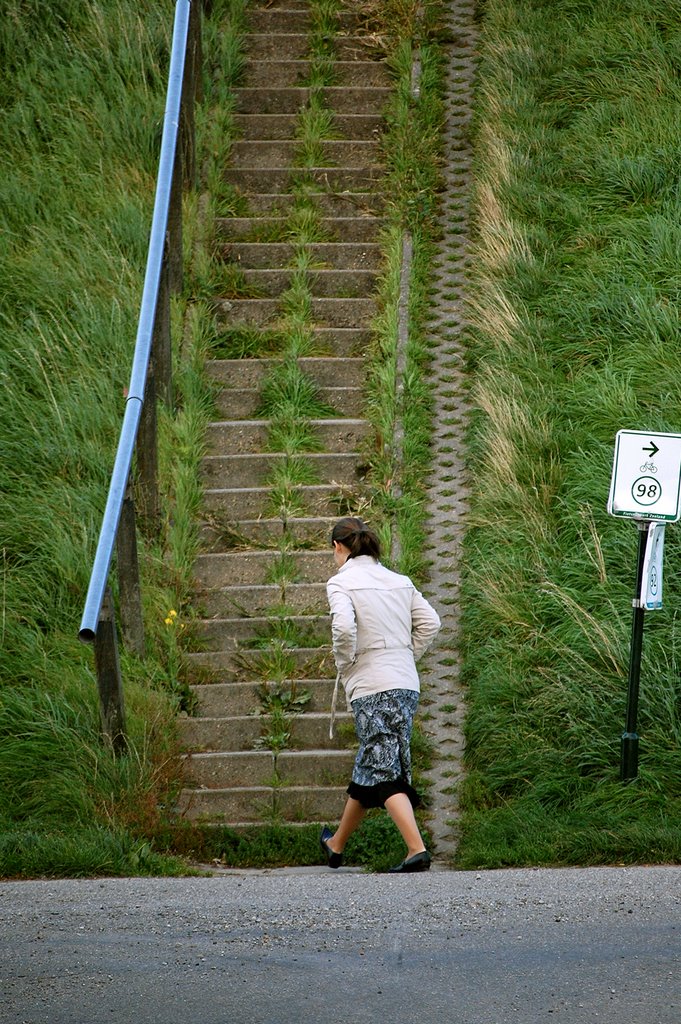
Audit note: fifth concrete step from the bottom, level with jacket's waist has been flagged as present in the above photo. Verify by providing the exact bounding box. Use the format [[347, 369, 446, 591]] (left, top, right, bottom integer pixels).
[[185, 647, 336, 684]]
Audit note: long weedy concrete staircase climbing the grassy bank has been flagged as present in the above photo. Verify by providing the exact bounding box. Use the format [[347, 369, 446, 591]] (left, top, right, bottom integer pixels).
[[179, 0, 389, 825]]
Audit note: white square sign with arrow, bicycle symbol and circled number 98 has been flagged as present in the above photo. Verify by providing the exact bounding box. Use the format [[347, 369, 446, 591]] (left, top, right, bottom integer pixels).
[[607, 430, 681, 522]]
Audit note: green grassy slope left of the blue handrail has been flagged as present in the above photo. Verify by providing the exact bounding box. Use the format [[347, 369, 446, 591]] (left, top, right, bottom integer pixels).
[[0, 0, 196, 873]]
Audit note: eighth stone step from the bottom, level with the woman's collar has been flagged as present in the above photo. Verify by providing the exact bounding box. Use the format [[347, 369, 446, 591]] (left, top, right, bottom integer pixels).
[[194, 545, 336, 590]]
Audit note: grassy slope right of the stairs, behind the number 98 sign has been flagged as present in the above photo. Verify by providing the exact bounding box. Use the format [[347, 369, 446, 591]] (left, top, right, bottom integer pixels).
[[461, 0, 681, 866]]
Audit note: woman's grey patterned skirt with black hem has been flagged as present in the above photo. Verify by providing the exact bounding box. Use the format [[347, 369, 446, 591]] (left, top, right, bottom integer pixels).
[[347, 690, 420, 808]]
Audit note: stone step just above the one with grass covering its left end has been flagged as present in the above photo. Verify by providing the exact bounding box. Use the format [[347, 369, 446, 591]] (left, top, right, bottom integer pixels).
[[214, 298, 378, 327]]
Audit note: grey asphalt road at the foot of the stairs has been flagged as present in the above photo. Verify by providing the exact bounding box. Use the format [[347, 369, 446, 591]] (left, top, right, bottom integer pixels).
[[0, 867, 681, 1024]]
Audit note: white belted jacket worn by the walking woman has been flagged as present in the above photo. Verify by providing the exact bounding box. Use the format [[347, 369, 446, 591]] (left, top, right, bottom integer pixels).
[[327, 555, 440, 703]]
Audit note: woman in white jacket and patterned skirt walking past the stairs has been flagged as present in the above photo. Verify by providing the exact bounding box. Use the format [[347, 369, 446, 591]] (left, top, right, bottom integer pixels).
[[320, 517, 440, 872]]
